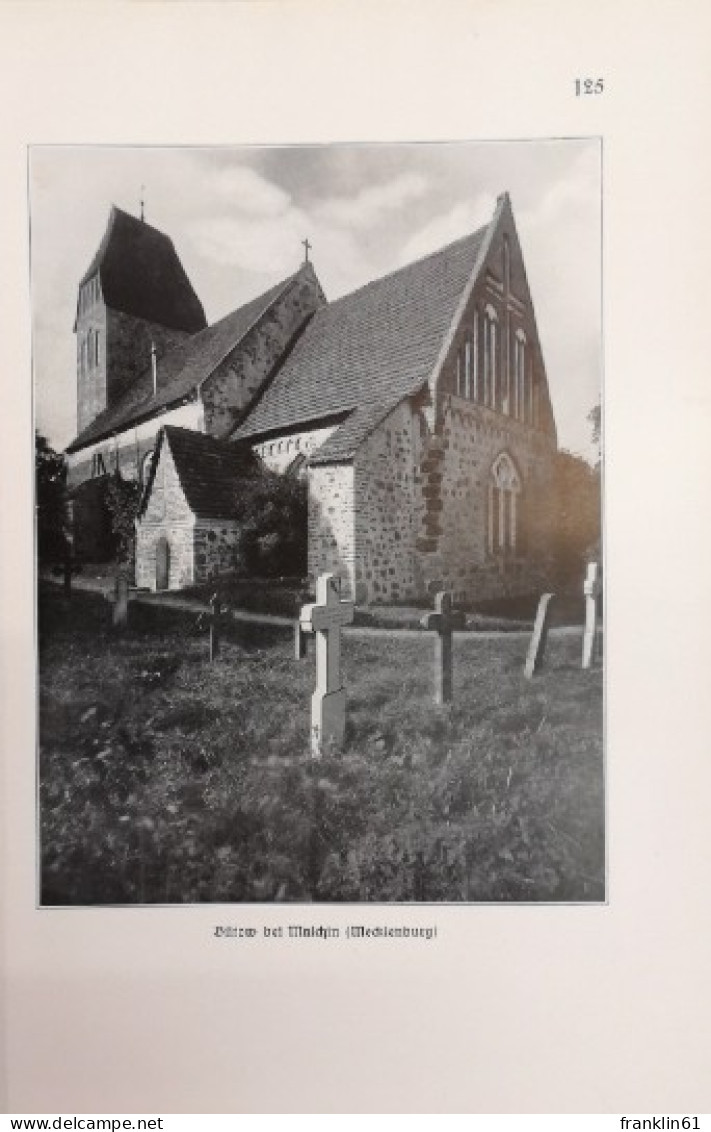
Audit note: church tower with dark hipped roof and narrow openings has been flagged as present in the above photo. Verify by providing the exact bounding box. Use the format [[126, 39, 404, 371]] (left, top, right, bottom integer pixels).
[[74, 206, 207, 434]]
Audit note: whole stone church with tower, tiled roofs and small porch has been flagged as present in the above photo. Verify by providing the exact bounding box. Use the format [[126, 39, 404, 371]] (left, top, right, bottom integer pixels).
[[67, 194, 556, 603]]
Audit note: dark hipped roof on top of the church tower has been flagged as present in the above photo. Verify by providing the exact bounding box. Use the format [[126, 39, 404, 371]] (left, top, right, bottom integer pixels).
[[79, 205, 206, 334]]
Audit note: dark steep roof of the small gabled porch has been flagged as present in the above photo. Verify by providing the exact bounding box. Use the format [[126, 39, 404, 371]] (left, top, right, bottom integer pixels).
[[138, 425, 262, 518]]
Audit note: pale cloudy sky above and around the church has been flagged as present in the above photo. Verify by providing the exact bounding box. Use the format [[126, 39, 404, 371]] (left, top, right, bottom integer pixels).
[[29, 139, 601, 455]]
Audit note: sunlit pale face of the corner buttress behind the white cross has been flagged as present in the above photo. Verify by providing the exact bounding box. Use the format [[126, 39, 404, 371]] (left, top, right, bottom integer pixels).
[[308, 464, 356, 598]]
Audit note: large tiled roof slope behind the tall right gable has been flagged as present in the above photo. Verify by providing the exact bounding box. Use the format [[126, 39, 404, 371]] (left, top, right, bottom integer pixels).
[[233, 218, 490, 452]]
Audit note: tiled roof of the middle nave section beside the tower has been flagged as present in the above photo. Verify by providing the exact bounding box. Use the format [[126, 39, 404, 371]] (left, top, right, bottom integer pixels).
[[67, 268, 302, 452]]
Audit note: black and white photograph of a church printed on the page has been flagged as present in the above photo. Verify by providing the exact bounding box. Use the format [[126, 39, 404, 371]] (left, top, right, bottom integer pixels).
[[28, 136, 607, 908]]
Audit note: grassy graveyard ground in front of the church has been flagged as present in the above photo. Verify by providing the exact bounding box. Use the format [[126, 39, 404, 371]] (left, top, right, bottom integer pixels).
[[38, 593, 605, 906]]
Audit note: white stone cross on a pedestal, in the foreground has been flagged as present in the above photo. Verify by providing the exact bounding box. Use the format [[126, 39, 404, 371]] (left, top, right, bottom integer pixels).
[[299, 574, 356, 756]]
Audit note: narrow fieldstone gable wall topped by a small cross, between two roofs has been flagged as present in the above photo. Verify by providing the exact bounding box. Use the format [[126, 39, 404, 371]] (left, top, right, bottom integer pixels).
[[202, 272, 323, 437]]
